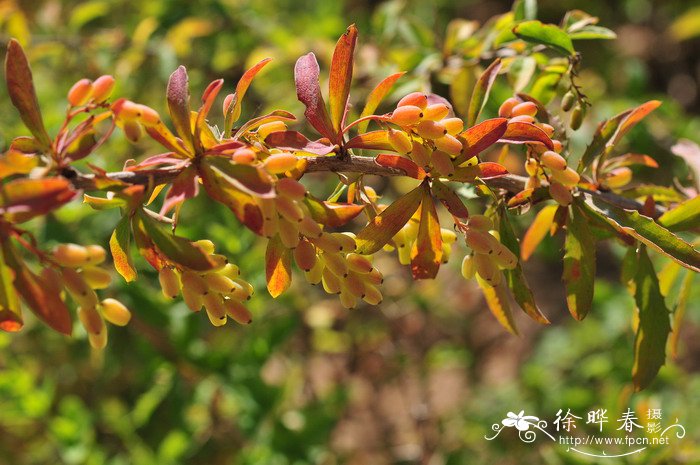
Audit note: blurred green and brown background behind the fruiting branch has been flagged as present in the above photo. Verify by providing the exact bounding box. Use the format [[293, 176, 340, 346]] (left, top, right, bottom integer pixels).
[[0, 0, 700, 465]]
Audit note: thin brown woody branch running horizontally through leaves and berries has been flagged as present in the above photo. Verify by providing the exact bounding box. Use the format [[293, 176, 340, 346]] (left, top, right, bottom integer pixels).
[[68, 155, 663, 217]]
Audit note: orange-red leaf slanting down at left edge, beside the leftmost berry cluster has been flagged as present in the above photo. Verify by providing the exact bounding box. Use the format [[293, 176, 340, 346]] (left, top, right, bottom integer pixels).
[[2, 240, 73, 336]]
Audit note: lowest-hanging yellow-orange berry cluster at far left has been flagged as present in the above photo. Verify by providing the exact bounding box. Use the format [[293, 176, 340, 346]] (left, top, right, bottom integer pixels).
[[50, 244, 131, 349]]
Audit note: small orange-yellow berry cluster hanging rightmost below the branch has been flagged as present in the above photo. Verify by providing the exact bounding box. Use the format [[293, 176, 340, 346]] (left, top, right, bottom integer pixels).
[[462, 215, 518, 286]]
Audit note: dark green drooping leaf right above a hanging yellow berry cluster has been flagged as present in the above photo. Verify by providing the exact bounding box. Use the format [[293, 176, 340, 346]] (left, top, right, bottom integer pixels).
[[137, 211, 215, 271]]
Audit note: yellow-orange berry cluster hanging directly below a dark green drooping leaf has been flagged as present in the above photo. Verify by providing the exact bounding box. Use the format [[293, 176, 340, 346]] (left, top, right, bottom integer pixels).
[[158, 239, 253, 326]]
